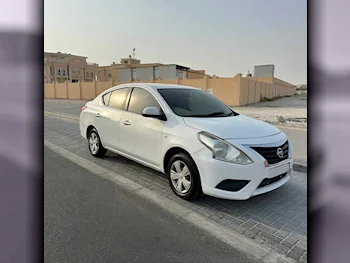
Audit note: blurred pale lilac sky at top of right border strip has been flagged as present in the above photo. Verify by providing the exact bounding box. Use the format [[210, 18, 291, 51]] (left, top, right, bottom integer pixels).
[[312, 0, 350, 73]]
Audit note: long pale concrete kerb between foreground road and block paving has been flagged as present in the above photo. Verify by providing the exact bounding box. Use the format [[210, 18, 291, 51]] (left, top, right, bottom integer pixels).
[[44, 140, 296, 263]]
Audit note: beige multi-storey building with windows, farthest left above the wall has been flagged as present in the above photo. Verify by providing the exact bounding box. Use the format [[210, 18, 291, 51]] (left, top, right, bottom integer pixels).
[[44, 52, 98, 83]]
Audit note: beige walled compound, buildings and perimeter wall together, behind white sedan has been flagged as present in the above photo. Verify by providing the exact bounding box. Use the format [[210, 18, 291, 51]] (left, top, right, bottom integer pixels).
[[44, 53, 296, 106]]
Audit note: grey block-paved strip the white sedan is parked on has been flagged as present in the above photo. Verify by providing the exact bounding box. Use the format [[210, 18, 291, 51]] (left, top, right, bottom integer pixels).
[[44, 115, 307, 262]]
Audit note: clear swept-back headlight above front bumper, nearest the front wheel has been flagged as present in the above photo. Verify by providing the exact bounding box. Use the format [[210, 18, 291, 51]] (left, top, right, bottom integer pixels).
[[198, 132, 253, 164]]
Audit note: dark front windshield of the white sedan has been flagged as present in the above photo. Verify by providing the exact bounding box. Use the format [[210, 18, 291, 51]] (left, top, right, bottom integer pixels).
[[158, 88, 238, 117]]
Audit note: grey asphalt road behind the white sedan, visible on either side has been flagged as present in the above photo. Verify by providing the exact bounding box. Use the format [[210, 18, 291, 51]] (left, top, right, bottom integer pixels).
[[44, 100, 307, 164]]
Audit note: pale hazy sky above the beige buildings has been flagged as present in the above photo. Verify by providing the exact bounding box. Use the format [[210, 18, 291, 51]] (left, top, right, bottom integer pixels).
[[44, 0, 307, 84]]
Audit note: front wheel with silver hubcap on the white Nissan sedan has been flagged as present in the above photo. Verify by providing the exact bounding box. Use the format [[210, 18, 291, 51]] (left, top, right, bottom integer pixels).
[[166, 153, 202, 201]]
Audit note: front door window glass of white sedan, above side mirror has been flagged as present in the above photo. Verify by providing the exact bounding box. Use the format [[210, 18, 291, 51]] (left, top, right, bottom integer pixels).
[[128, 88, 161, 114]]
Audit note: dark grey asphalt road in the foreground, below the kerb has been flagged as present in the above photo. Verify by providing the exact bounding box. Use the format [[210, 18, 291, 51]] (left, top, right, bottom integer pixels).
[[44, 148, 254, 263]]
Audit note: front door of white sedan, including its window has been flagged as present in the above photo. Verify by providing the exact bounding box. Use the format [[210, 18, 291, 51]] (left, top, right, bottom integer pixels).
[[119, 88, 164, 167]]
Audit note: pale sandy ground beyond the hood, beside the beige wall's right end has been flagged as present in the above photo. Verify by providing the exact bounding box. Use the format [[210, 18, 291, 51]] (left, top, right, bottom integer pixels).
[[232, 94, 307, 129]]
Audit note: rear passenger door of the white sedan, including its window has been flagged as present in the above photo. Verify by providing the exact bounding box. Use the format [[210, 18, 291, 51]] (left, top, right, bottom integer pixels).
[[95, 87, 130, 150]]
